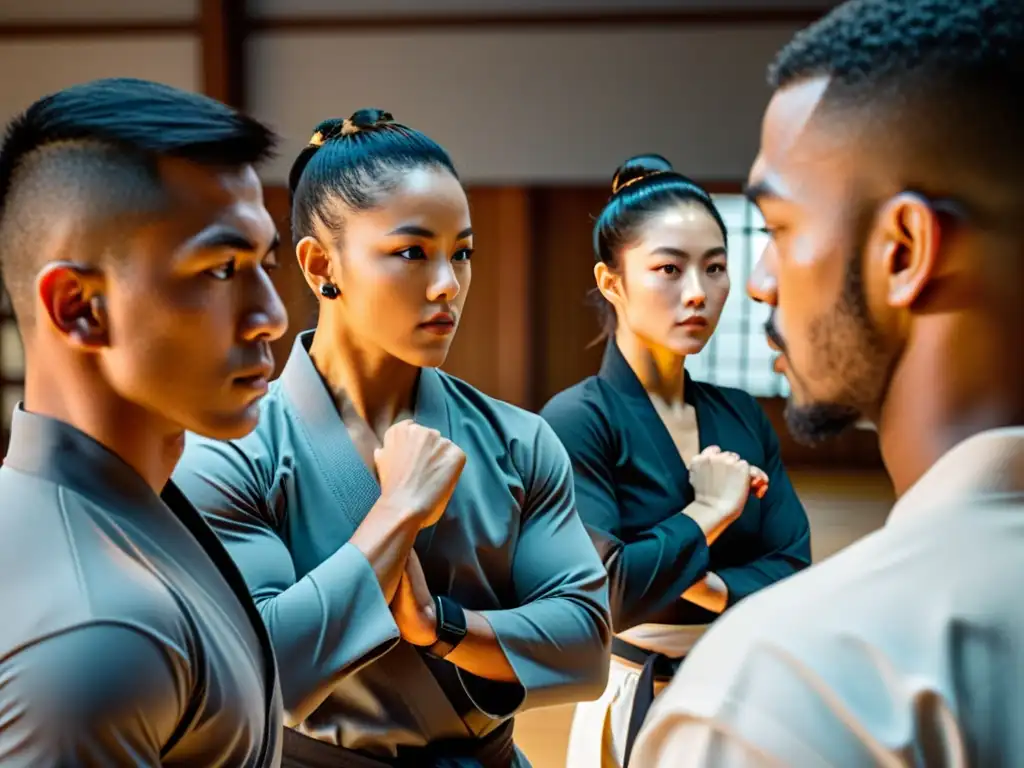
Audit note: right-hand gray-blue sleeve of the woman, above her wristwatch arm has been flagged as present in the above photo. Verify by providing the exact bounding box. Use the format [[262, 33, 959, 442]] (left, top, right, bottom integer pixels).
[[460, 419, 611, 714]]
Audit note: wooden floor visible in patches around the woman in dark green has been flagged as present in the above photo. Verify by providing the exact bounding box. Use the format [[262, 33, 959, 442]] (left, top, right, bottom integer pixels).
[[515, 472, 893, 768]]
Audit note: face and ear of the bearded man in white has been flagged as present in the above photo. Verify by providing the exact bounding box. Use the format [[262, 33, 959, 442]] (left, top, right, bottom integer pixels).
[[748, 78, 913, 443]]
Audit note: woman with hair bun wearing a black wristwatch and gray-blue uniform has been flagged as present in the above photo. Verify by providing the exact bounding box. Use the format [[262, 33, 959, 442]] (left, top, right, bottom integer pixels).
[[175, 110, 610, 768]]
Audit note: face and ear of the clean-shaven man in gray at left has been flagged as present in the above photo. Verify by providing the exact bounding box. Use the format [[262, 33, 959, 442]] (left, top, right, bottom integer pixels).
[[37, 160, 288, 439]]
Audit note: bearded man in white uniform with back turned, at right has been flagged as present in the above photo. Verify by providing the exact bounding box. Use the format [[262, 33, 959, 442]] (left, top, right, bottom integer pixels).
[[634, 0, 1024, 768]]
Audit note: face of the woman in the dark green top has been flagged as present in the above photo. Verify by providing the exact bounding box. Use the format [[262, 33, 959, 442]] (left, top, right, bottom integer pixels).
[[594, 202, 729, 355]]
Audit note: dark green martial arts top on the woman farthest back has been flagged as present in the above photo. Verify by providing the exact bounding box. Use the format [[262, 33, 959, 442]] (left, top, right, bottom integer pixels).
[[541, 339, 811, 632]]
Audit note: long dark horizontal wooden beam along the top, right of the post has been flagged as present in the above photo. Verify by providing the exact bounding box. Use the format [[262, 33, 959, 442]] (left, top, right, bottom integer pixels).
[[251, 7, 828, 33]]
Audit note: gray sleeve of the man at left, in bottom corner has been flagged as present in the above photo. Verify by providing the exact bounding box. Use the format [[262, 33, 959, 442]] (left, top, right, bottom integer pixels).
[[0, 625, 190, 768]]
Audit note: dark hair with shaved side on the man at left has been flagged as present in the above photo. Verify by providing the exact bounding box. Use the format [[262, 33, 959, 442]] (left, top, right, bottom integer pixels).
[[0, 78, 275, 329]]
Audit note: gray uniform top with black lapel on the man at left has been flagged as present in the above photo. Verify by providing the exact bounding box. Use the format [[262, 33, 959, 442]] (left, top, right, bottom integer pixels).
[[0, 407, 283, 768]]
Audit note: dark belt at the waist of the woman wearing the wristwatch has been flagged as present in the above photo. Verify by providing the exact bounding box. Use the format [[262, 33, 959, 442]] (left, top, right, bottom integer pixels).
[[281, 720, 515, 768]]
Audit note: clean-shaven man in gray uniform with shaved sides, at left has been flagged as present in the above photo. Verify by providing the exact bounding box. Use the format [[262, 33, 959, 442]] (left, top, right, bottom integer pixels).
[[0, 79, 287, 768]]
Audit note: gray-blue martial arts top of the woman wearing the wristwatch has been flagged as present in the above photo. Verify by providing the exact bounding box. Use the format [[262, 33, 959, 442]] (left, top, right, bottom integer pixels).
[[174, 333, 609, 767]]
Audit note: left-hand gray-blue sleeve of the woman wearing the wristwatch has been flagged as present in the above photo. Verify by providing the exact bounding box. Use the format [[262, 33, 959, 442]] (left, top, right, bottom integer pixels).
[[173, 435, 399, 726]]
